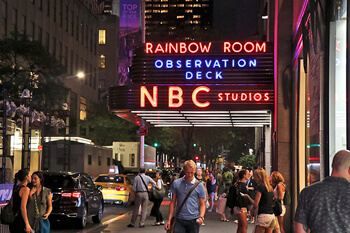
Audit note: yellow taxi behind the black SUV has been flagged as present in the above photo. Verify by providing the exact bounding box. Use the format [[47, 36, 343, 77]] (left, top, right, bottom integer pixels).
[[95, 174, 135, 206]]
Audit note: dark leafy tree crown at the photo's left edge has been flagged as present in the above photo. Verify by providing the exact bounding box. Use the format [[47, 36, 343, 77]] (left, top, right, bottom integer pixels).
[[0, 32, 67, 109]]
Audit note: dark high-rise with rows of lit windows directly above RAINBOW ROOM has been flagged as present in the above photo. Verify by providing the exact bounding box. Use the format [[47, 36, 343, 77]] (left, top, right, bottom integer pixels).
[[145, 0, 213, 41]]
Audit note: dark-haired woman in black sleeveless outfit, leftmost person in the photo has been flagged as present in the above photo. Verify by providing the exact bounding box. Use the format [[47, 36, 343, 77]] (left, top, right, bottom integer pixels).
[[9, 168, 33, 233]]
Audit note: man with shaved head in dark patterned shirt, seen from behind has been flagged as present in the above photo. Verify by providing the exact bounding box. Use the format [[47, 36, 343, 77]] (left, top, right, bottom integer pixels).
[[294, 150, 350, 233]]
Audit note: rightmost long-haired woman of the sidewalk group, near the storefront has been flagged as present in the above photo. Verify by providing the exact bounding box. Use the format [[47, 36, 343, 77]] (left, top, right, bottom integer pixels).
[[271, 171, 286, 233]]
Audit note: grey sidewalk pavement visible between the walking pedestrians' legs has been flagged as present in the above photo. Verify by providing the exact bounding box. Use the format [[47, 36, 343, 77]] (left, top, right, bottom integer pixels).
[[87, 198, 254, 233]]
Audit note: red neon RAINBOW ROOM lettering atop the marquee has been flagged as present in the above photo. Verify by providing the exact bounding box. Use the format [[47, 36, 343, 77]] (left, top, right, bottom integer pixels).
[[144, 41, 273, 55]]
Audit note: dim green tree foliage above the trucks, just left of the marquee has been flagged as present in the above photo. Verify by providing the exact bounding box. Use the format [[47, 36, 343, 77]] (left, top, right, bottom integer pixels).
[[81, 101, 139, 146]]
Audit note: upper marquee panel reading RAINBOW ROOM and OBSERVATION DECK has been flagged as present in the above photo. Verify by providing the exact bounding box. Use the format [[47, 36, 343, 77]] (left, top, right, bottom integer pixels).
[[130, 41, 274, 84]]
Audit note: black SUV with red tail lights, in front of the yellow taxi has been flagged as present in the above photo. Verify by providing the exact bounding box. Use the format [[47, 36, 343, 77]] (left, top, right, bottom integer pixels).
[[44, 172, 104, 228]]
